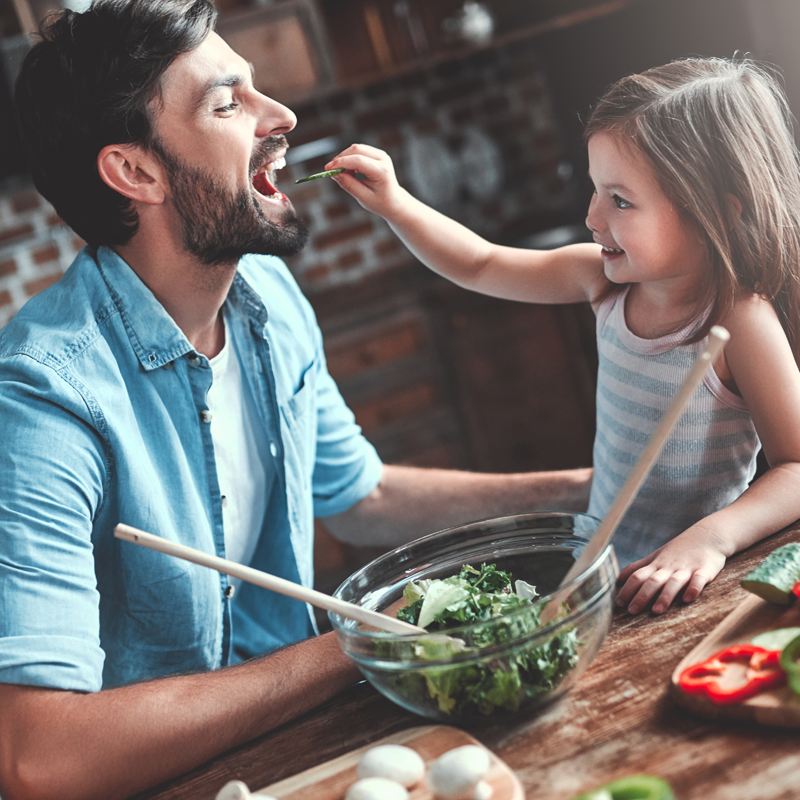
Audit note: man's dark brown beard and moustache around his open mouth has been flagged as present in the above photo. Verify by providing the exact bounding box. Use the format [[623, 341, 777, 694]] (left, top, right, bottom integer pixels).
[[150, 136, 308, 266]]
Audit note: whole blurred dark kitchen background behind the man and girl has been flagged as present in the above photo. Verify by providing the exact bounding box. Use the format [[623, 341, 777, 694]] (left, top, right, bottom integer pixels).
[[0, 0, 800, 588]]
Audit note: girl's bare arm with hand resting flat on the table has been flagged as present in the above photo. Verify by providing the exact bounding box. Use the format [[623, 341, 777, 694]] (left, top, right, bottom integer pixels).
[[617, 296, 800, 614]]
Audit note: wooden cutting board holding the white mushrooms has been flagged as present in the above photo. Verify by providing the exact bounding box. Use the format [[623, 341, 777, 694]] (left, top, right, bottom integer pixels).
[[254, 725, 525, 800]]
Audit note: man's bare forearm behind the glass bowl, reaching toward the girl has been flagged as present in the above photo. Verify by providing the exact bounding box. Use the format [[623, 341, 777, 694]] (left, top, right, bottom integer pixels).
[[324, 465, 592, 547]]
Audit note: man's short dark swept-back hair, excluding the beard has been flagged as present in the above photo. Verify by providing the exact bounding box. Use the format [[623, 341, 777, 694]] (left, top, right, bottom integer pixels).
[[16, 0, 217, 246]]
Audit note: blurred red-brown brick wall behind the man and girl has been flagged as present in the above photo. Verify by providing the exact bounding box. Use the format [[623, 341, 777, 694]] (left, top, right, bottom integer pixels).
[[0, 33, 570, 326]]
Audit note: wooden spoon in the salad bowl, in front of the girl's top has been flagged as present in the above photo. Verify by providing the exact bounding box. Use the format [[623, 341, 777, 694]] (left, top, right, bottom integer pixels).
[[540, 325, 731, 625]]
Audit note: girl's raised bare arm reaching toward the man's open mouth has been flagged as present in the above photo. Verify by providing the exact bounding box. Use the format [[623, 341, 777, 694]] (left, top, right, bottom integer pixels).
[[325, 144, 607, 303]]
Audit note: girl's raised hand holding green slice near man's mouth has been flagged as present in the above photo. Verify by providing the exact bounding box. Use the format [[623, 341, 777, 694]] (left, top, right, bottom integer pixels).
[[325, 144, 406, 219]]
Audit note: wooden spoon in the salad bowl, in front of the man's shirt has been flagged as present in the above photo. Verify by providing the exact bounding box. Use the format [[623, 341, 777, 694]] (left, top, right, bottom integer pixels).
[[114, 523, 427, 636]]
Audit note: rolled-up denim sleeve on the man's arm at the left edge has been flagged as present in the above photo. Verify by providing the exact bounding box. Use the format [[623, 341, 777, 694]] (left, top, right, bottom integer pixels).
[[0, 355, 106, 691]]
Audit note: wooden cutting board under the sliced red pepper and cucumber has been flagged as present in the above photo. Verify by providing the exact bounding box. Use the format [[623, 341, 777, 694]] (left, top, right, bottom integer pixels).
[[670, 594, 800, 728]]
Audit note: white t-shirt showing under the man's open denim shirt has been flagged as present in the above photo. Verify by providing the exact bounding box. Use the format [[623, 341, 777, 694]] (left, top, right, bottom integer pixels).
[[207, 313, 271, 586]]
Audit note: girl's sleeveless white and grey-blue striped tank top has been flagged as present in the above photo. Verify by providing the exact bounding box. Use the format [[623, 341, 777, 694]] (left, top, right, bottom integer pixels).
[[589, 287, 760, 567]]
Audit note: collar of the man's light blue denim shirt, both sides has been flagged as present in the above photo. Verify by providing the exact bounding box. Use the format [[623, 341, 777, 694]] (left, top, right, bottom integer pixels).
[[95, 247, 268, 371]]
